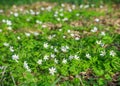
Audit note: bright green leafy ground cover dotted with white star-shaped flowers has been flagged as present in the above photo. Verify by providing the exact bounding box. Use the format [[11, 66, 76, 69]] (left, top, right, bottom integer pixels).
[[0, 2, 120, 86]]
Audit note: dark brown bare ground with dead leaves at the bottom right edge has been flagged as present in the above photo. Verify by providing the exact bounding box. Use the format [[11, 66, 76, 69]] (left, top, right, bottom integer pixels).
[[56, 69, 120, 86]]
